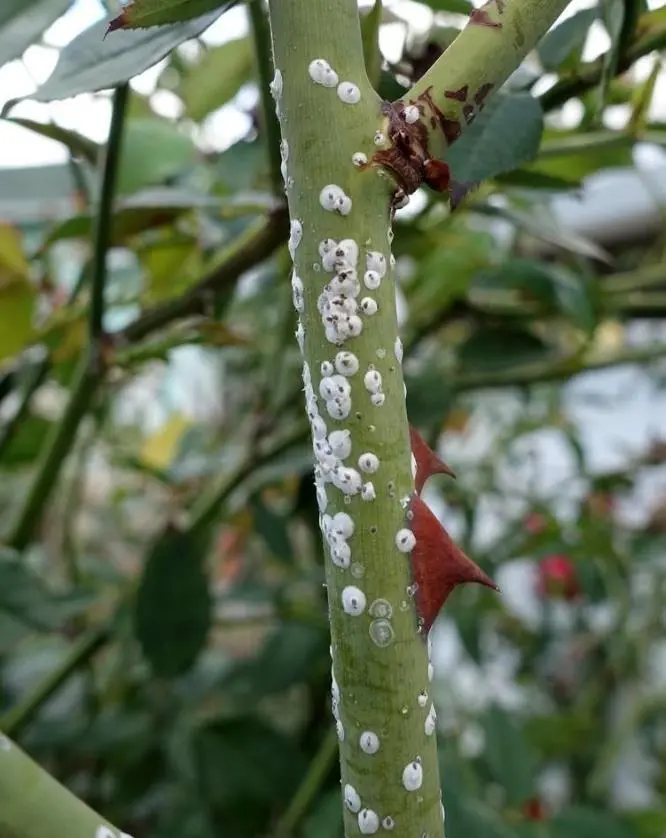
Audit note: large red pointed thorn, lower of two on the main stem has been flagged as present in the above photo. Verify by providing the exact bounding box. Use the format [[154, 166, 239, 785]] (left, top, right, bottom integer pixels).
[[407, 494, 499, 636]]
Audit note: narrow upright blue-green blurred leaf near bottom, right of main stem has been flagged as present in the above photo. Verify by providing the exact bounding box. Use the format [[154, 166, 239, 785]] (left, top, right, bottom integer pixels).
[[483, 706, 537, 806]]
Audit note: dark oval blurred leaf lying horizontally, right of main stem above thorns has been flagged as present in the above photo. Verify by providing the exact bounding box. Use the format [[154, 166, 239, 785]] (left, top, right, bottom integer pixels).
[[458, 326, 554, 372]]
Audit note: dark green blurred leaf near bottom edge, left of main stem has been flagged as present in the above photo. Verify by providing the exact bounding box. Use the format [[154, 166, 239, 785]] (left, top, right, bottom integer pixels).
[[192, 718, 305, 809]]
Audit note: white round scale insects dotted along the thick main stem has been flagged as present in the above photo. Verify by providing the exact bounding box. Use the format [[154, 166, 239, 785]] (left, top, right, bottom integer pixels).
[[272, 59, 444, 835]]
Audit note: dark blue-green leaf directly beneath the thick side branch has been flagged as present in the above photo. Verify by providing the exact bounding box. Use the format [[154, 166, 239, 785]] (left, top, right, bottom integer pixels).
[[446, 93, 543, 187]]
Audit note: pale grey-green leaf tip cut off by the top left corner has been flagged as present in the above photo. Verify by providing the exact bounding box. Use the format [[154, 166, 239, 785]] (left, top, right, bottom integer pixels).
[[0, 0, 71, 64]]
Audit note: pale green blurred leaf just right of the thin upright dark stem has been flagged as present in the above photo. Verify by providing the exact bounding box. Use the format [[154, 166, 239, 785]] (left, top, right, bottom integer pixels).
[[118, 117, 197, 194]]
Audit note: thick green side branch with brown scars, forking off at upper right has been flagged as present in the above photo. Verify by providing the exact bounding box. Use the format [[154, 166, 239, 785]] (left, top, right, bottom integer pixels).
[[403, 0, 569, 162]]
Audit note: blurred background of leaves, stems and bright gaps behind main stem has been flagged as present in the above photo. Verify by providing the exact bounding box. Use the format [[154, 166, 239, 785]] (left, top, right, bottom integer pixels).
[[0, 0, 666, 838]]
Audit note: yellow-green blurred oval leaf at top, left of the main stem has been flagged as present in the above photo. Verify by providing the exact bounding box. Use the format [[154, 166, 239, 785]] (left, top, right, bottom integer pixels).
[[176, 38, 254, 122]]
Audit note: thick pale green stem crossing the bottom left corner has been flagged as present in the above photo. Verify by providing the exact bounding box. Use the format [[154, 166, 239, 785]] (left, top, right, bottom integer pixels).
[[0, 734, 124, 838]]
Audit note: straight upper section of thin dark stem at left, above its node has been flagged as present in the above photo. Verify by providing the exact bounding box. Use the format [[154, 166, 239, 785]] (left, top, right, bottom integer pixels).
[[88, 84, 130, 345]]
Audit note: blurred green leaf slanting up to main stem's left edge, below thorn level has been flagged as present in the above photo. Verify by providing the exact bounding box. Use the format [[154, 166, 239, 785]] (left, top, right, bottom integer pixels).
[[220, 622, 328, 702]]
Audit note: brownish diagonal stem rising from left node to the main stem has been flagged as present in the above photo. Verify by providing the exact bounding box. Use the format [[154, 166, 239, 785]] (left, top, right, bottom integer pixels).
[[113, 209, 287, 347]]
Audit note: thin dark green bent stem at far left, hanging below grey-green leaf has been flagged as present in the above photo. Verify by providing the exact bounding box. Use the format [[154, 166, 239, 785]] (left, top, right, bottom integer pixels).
[[7, 86, 127, 550]]
